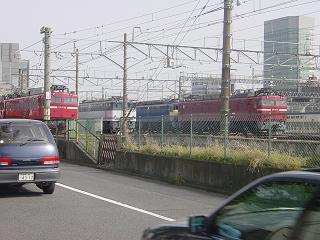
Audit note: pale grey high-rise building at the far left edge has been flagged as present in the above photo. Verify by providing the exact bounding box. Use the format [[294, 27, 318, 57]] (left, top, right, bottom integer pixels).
[[0, 43, 20, 89]]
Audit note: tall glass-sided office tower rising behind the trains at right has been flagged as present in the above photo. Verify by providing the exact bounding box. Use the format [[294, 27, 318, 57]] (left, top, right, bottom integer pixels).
[[264, 16, 315, 89]]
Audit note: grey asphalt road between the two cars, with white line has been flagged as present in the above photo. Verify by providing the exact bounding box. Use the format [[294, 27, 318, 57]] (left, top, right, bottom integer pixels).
[[0, 164, 226, 240]]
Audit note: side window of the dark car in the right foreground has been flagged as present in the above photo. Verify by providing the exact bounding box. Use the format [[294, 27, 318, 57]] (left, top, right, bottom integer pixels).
[[210, 181, 317, 240]]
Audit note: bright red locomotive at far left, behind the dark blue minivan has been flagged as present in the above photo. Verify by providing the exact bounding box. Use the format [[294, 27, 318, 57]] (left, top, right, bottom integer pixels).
[[0, 85, 79, 120]]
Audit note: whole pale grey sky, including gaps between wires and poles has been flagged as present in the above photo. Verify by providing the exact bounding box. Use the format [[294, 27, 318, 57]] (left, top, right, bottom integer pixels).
[[0, 0, 320, 98]]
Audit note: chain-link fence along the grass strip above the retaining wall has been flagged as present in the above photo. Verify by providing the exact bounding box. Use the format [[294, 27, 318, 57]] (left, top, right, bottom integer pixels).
[[125, 112, 320, 168]]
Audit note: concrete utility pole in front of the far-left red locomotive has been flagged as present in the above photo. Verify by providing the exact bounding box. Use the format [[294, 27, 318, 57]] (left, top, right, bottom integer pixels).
[[40, 27, 52, 121]]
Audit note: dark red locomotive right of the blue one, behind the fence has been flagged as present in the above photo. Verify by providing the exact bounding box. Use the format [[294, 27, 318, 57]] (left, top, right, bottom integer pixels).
[[178, 90, 288, 134]]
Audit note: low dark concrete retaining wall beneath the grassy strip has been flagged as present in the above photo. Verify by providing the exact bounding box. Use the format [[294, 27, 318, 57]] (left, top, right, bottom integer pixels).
[[114, 152, 280, 194]]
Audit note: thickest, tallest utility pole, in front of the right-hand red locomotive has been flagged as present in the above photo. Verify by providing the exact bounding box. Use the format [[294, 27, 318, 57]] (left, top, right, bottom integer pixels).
[[220, 0, 232, 159]]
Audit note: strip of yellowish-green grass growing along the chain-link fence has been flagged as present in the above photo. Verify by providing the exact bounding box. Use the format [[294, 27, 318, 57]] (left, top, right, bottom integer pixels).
[[126, 143, 313, 171]]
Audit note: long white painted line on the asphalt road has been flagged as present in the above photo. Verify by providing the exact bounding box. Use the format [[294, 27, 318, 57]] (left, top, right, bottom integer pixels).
[[56, 183, 176, 222]]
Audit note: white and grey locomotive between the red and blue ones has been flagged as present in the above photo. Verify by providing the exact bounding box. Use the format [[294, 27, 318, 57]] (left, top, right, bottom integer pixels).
[[79, 97, 136, 134]]
